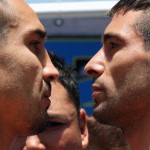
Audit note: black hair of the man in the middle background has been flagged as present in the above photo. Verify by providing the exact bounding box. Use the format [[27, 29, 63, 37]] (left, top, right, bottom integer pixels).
[[48, 51, 80, 114]]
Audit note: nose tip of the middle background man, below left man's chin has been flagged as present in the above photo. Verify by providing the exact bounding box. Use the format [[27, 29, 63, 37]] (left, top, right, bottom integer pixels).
[[24, 135, 46, 150]]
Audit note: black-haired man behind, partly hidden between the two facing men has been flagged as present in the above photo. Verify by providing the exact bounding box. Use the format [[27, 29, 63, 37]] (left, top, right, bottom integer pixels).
[[11, 52, 88, 150]]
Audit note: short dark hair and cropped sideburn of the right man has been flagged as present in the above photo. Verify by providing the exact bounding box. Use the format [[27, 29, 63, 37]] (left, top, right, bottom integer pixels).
[[108, 0, 150, 50]]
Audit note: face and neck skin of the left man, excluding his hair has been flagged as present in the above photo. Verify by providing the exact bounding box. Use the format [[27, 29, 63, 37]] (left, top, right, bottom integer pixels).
[[0, 0, 58, 150]]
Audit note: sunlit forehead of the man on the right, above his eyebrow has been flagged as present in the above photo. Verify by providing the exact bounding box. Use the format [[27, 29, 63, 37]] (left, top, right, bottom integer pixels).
[[104, 11, 142, 38]]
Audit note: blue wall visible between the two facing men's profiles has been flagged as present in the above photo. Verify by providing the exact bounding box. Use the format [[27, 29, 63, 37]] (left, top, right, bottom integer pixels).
[[45, 38, 101, 115]]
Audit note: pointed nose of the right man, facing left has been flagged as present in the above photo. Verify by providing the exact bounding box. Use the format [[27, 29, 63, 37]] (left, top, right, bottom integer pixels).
[[84, 49, 105, 78]]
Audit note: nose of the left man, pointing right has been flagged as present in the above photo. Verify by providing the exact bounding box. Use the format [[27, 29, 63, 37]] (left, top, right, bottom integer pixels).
[[43, 53, 59, 81]]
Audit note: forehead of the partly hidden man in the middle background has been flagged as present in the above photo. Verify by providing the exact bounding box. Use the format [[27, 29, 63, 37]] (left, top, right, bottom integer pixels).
[[47, 82, 77, 122]]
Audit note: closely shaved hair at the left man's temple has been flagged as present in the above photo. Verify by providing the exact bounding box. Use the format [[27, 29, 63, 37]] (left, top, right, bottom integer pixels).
[[0, 0, 15, 46]]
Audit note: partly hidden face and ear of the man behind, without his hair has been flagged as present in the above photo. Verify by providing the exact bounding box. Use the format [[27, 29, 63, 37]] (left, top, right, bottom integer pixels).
[[11, 82, 88, 150]]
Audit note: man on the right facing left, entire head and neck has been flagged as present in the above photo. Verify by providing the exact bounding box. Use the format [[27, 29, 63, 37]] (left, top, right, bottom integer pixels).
[[85, 0, 150, 150]]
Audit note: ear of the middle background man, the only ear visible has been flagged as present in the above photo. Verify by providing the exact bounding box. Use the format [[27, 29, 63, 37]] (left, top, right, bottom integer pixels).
[[80, 108, 89, 149]]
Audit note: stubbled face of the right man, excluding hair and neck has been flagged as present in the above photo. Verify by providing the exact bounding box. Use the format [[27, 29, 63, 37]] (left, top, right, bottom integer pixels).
[[85, 11, 150, 127]]
